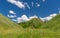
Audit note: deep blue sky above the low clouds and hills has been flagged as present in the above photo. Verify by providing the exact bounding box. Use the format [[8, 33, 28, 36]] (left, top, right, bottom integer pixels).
[[0, 0, 60, 22]]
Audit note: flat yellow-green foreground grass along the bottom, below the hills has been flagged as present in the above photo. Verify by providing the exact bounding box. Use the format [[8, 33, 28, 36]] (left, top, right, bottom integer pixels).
[[0, 29, 60, 38]]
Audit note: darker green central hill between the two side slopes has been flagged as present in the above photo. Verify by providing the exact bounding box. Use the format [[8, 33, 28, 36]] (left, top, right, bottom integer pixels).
[[18, 18, 44, 28]]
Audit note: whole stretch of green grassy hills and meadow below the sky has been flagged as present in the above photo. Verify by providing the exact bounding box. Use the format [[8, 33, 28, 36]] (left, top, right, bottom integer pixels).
[[0, 14, 60, 38]]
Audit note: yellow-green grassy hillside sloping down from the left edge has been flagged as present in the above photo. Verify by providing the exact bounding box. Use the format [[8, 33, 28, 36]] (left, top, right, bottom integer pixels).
[[0, 14, 22, 30]]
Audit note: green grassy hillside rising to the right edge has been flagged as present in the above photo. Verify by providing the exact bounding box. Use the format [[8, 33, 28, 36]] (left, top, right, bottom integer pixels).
[[41, 14, 60, 30]]
